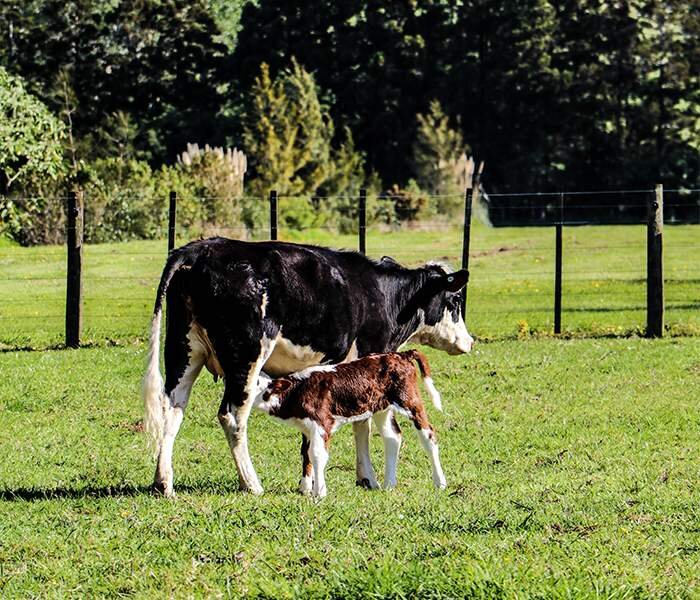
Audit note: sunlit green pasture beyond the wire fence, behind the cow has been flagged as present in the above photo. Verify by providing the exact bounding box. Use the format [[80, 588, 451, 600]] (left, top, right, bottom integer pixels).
[[0, 223, 700, 348]]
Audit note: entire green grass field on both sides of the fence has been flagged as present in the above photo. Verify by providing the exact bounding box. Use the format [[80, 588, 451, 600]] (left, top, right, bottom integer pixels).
[[0, 226, 700, 598]]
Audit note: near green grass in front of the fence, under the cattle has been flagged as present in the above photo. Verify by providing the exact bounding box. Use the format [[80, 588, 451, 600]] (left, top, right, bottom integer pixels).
[[0, 338, 700, 598]]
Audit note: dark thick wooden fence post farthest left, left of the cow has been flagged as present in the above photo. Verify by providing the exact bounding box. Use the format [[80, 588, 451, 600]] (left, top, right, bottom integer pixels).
[[66, 191, 83, 348]]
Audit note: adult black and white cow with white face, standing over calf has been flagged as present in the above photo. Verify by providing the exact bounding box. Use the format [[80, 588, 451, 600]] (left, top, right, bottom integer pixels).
[[143, 238, 473, 496]]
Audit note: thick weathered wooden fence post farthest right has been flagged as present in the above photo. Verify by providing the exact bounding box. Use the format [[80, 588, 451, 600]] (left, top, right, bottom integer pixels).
[[647, 184, 664, 337]]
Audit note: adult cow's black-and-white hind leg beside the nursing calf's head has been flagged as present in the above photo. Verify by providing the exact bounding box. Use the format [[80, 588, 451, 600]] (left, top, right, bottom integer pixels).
[[219, 336, 275, 494]]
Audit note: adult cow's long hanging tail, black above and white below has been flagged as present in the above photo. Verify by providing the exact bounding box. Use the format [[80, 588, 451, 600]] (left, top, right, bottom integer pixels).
[[141, 250, 185, 454]]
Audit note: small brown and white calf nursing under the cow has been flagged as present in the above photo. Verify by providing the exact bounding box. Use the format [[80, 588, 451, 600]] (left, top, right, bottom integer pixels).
[[255, 350, 447, 497]]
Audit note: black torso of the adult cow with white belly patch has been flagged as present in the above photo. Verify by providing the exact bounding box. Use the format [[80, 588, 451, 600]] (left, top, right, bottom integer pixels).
[[172, 238, 385, 376]]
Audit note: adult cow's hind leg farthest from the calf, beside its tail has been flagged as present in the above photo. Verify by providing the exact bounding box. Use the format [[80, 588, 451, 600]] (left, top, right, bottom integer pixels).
[[153, 328, 204, 497]]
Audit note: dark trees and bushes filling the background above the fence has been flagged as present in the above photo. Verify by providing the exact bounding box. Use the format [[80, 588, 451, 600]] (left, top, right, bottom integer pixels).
[[0, 0, 700, 243]]
